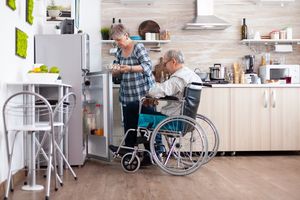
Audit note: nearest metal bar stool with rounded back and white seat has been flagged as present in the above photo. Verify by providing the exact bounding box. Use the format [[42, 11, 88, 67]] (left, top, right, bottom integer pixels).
[[2, 91, 57, 199]]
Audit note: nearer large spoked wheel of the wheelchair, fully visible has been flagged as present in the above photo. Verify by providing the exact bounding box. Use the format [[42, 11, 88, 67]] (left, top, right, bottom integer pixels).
[[150, 115, 207, 175]]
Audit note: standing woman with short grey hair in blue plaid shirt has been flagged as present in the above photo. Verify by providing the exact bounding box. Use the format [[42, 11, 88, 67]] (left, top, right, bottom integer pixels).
[[111, 24, 154, 147]]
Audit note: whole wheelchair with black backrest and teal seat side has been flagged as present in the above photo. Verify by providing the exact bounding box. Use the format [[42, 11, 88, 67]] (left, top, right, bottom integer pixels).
[[110, 83, 219, 176]]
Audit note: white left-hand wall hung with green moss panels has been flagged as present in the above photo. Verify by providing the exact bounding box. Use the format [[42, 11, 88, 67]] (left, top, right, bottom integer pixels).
[[0, 0, 42, 182]]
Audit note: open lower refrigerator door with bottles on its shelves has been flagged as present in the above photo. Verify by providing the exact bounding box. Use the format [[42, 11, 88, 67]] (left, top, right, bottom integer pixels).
[[83, 72, 113, 160]]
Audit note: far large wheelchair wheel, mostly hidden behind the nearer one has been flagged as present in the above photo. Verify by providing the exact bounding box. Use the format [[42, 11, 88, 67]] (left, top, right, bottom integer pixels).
[[196, 114, 220, 163]]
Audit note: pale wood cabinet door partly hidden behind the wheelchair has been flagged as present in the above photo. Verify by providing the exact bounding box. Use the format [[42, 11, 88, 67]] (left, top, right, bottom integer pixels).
[[198, 88, 231, 151]]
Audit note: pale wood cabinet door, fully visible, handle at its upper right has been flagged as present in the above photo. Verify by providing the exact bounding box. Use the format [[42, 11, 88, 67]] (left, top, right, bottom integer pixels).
[[231, 88, 271, 151]]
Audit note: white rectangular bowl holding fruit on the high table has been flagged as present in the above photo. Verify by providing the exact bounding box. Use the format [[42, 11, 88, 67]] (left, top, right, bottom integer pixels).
[[26, 73, 59, 83]]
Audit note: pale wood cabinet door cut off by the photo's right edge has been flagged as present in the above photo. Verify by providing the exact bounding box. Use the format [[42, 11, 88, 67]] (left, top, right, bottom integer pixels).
[[270, 88, 300, 150]]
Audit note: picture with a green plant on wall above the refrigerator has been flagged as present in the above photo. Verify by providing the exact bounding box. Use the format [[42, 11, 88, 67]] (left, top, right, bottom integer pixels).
[[46, 0, 72, 22]]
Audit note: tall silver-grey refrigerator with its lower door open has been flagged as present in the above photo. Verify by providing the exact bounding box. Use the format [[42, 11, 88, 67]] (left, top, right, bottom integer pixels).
[[34, 34, 113, 165]]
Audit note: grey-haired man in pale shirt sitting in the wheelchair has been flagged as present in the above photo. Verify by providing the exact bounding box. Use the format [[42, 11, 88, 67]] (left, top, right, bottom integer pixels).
[[148, 50, 202, 116]]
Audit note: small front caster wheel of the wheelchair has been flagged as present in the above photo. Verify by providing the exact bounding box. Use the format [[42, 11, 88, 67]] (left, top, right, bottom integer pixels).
[[121, 153, 141, 173]]
